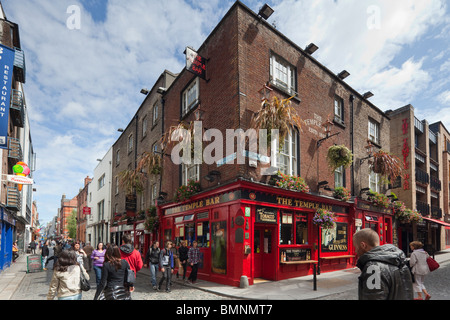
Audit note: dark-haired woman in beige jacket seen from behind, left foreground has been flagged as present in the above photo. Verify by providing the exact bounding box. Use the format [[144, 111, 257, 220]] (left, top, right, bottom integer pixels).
[[47, 250, 89, 300]]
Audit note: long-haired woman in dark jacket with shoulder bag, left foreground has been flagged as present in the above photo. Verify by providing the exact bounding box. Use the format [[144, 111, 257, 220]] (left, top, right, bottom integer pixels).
[[94, 244, 134, 300]]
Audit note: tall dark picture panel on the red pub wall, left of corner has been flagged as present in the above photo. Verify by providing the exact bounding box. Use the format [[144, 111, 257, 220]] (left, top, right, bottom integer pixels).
[[211, 221, 227, 274]]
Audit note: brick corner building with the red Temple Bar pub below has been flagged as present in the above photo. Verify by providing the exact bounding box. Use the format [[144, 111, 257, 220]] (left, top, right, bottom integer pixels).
[[155, 1, 393, 285]]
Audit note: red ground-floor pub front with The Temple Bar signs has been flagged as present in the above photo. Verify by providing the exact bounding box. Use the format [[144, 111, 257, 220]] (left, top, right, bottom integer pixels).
[[158, 181, 355, 286]]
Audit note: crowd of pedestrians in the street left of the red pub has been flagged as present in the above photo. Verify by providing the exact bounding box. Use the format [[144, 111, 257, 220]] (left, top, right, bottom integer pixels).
[[41, 234, 200, 300]]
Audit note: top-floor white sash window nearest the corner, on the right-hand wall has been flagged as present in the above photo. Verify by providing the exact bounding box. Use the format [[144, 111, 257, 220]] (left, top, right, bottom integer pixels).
[[270, 54, 297, 95]]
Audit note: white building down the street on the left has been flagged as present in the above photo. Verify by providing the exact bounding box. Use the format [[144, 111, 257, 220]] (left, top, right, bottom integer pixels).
[[86, 147, 112, 247]]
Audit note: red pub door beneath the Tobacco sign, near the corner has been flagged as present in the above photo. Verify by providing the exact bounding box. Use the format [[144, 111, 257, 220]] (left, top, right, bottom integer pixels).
[[253, 226, 277, 280]]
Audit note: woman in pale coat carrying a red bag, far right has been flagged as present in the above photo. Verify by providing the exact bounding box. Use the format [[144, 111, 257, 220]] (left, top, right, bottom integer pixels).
[[409, 241, 431, 300]]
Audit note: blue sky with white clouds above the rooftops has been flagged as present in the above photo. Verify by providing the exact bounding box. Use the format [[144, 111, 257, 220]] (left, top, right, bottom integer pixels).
[[2, 0, 450, 225]]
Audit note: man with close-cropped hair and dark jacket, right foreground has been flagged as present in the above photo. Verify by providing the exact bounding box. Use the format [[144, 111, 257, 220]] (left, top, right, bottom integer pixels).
[[353, 228, 414, 300]]
